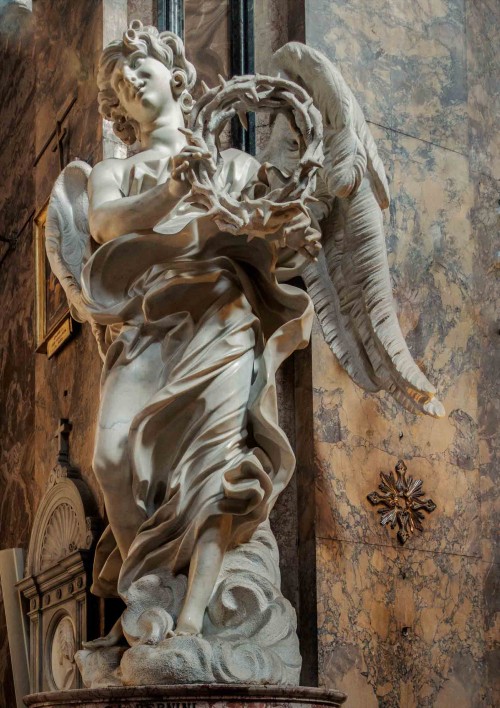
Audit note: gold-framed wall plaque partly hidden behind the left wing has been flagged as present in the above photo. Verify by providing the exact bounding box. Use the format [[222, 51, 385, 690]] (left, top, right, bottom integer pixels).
[[34, 201, 77, 358]]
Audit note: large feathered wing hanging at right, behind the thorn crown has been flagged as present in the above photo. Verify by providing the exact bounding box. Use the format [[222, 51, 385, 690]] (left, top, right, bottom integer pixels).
[[274, 42, 444, 417]]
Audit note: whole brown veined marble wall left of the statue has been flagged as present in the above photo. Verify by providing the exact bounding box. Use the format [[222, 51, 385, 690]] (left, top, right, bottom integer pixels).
[[0, 0, 113, 708]]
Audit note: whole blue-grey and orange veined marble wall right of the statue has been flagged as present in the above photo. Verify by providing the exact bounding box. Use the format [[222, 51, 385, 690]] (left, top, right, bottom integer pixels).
[[305, 0, 500, 708]]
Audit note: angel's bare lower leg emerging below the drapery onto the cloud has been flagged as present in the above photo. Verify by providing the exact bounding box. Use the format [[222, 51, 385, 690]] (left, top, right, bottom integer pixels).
[[175, 514, 232, 635]]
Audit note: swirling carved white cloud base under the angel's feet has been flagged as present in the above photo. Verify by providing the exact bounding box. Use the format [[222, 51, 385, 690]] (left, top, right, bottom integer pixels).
[[75, 523, 301, 689]]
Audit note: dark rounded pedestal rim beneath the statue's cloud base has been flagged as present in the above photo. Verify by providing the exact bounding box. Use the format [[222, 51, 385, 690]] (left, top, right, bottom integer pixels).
[[24, 684, 346, 708]]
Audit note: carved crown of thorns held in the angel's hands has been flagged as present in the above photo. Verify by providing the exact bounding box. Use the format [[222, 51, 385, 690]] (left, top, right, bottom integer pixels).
[[180, 75, 323, 238]]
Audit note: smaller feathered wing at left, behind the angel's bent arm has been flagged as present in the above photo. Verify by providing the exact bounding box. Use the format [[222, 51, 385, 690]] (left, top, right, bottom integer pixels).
[[45, 160, 105, 356]]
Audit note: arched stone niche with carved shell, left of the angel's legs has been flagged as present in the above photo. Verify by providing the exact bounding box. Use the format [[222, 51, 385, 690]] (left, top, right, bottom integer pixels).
[[17, 451, 99, 691]]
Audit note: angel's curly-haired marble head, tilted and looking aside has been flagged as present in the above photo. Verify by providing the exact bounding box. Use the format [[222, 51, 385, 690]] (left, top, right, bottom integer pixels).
[[97, 20, 196, 145]]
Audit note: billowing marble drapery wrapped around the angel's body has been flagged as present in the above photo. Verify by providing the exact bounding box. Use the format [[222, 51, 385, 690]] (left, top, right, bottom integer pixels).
[[82, 151, 313, 596]]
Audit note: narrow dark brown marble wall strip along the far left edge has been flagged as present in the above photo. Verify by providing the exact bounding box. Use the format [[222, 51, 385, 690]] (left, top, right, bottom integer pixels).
[[0, 4, 35, 708]]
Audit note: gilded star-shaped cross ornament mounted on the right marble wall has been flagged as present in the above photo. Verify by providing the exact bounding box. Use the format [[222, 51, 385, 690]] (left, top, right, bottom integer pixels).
[[367, 460, 436, 545]]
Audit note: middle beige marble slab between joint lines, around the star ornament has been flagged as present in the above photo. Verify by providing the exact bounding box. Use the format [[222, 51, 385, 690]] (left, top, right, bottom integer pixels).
[[312, 126, 481, 555]]
